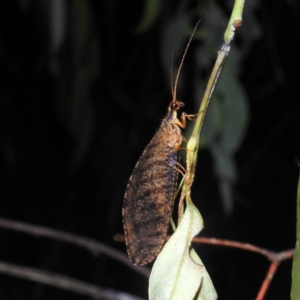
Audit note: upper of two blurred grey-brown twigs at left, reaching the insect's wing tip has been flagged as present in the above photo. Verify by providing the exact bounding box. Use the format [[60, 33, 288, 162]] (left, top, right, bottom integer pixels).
[[0, 218, 150, 278]]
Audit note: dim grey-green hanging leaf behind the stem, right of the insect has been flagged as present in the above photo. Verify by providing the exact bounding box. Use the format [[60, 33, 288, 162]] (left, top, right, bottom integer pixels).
[[202, 55, 249, 212]]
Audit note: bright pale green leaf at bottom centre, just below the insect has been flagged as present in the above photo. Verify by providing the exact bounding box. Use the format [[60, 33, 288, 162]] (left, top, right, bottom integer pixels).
[[149, 201, 212, 300]]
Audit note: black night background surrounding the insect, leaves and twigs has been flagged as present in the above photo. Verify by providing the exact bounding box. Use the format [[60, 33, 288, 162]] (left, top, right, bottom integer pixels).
[[0, 0, 300, 300]]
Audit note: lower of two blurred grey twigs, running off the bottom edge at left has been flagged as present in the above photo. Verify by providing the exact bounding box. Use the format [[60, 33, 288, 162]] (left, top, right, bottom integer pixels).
[[0, 261, 142, 300]]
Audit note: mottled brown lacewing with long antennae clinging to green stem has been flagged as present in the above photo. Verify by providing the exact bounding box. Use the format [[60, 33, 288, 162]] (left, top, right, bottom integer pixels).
[[123, 22, 199, 265]]
